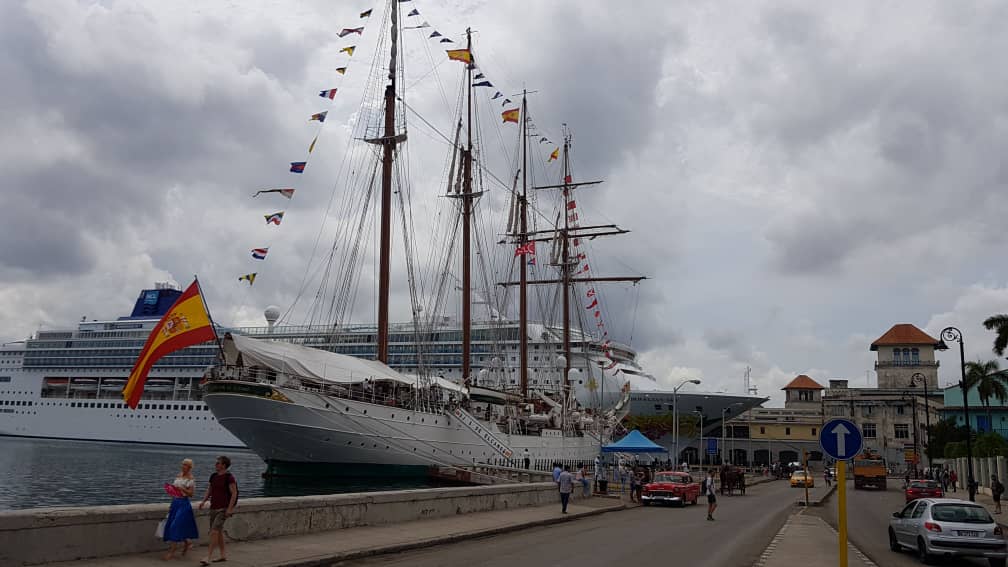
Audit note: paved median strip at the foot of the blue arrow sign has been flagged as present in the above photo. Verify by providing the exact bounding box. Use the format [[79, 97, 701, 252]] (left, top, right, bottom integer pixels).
[[753, 511, 878, 567]]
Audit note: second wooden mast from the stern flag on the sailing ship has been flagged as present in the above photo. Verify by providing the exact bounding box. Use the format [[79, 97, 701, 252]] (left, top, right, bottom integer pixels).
[[462, 28, 475, 383]]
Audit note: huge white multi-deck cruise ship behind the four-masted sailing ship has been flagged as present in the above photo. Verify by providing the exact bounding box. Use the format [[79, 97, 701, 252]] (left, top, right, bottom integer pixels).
[[0, 285, 646, 447]]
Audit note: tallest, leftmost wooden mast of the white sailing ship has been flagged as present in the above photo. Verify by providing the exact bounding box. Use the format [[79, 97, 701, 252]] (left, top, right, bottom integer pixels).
[[369, 0, 404, 363]]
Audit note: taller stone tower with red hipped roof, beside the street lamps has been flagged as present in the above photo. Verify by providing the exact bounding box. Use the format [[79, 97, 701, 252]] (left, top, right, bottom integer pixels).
[[871, 323, 938, 391]]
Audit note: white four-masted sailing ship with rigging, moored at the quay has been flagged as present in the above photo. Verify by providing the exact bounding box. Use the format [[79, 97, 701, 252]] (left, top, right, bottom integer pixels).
[[204, 6, 643, 476]]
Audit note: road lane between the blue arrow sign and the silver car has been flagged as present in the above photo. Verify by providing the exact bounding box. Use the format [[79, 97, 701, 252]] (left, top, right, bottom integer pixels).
[[813, 478, 987, 567]]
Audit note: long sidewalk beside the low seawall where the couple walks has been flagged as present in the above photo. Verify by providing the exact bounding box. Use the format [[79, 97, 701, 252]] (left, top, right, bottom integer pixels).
[[55, 497, 624, 567]]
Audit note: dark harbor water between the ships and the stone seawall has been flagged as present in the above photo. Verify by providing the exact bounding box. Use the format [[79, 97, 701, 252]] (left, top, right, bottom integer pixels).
[[0, 437, 432, 509]]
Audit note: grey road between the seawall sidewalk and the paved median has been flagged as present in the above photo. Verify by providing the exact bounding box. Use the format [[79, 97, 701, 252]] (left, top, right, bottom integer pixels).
[[339, 480, 823, 567]]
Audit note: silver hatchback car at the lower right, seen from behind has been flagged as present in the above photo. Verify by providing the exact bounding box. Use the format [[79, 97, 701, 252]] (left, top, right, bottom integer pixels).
[[889, 498, 1008, 567]]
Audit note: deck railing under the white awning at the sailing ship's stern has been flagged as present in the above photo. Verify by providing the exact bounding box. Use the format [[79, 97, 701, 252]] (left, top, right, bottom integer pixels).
[[208, 365, 456, 414]]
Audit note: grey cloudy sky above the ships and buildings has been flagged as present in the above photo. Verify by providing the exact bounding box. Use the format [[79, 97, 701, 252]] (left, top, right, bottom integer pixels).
[[0, 0, 1008, 402]]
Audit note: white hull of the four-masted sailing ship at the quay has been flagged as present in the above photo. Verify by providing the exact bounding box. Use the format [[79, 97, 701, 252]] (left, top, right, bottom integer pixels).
[[205, 386, 601, 476]]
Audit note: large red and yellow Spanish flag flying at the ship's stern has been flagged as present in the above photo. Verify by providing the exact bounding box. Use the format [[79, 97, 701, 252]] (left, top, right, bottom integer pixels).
[[123, 280, 217, 410]]
